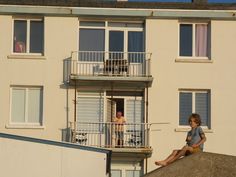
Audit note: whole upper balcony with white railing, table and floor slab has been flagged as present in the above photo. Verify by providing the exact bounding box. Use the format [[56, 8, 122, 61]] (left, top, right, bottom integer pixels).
[[66, 51, 153, 87]]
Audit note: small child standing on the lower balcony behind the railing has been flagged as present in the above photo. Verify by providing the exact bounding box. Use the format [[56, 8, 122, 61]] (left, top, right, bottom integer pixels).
[[113, 111, 126, 147]]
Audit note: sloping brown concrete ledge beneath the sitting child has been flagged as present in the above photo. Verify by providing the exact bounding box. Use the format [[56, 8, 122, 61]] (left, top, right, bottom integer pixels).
[[144, 152, 236, 177]]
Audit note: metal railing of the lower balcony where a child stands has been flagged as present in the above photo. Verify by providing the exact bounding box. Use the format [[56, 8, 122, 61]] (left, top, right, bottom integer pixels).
[[70, 122, 150, 148]]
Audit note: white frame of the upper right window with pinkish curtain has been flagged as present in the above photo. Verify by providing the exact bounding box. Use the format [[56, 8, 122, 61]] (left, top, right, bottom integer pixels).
[[177, 21, 211, 61]]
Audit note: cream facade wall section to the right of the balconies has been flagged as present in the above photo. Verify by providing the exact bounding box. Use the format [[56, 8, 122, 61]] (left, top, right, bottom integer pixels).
[[146, 19, 236, 170]]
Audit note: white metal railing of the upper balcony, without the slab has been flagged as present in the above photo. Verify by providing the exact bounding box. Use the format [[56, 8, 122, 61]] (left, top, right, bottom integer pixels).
[[70, 51, 151, 77]]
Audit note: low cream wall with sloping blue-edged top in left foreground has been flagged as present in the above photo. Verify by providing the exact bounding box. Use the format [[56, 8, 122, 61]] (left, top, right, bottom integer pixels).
[[0, 137, 107, 177]]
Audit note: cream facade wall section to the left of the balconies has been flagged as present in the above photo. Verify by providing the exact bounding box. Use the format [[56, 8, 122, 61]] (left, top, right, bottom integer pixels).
[[0, 16, 78, 140]]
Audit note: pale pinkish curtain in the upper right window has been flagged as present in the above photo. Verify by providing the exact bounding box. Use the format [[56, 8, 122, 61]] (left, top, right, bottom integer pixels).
[[195, 24, 207, 57]]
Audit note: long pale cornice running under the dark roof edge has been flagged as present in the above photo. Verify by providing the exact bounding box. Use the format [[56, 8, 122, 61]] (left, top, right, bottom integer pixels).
[[0, 5, 236, 20]]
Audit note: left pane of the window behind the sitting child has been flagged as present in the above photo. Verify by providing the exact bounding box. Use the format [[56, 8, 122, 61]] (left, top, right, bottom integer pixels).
[[179, 93, 192, 125]]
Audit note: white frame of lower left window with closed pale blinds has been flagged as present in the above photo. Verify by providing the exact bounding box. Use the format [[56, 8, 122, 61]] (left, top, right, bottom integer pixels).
[[7, 85, 44, 128]]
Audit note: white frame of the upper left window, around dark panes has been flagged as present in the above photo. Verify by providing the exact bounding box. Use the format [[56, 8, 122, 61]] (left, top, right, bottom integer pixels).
[[11, 17, 45, 56]]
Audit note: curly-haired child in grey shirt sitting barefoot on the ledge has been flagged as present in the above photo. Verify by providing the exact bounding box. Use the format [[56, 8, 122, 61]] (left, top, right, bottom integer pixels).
[[155, 114, 206, 166]]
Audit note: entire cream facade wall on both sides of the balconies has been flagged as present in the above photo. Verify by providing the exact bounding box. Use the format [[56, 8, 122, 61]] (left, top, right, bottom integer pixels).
[[0, 12, 236, 174]]
